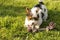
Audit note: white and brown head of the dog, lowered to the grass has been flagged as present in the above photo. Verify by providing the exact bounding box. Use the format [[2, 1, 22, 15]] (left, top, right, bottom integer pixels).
[[25, 8, 41, 29]]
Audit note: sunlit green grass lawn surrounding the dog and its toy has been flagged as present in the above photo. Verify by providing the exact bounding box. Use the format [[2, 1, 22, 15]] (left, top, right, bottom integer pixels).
[[0, 0, 60, 40]]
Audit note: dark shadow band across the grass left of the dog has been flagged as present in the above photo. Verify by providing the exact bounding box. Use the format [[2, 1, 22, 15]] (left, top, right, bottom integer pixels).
[[0, 5, 25, 17]]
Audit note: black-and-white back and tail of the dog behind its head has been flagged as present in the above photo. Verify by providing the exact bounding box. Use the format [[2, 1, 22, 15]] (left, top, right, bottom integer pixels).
[[32, 0, 48, 21]]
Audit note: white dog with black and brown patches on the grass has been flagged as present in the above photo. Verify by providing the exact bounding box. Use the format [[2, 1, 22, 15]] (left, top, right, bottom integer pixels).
[[25, 0, 48, 32]]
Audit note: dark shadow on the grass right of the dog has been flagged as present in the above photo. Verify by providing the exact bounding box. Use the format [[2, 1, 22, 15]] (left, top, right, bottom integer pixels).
[[41, 9, 60, 31]]
